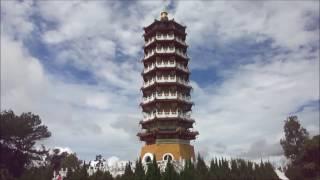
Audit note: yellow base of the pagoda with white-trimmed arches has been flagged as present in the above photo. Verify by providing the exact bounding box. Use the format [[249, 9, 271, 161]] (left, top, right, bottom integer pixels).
[[140, 144, 195, 161]]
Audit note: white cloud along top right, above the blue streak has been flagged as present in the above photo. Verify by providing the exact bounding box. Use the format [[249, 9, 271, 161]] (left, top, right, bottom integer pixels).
[[174, 1, 319, 48]]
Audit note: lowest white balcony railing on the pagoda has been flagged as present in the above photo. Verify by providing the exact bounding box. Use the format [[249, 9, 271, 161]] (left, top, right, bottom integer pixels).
[[143, 111, 192, 121]]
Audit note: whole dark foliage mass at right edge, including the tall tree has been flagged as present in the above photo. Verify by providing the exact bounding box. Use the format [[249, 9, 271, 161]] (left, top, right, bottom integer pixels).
[[280, 116, 320, 180]]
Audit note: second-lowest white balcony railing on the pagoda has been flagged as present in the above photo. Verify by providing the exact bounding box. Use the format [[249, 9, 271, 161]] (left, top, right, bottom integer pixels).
[[142, 92, 191, 104]]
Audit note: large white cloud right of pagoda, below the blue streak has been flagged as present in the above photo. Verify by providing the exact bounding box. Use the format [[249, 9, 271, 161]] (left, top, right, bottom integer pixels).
[[194, 47, 319, 159]]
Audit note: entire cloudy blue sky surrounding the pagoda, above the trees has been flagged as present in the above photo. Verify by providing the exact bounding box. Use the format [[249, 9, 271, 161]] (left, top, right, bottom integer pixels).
[[1, 0, 319, 163]]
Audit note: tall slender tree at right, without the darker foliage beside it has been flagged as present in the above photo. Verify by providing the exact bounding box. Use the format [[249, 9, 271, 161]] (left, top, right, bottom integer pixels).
[[280, 116, 308, 162]]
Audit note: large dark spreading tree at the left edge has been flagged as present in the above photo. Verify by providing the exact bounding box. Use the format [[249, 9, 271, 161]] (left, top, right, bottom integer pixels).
[[0, 111, 51, 177]]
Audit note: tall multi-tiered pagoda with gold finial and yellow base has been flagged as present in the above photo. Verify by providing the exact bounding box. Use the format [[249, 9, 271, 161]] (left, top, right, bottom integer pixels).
[[138, 12, 198, 162]]
